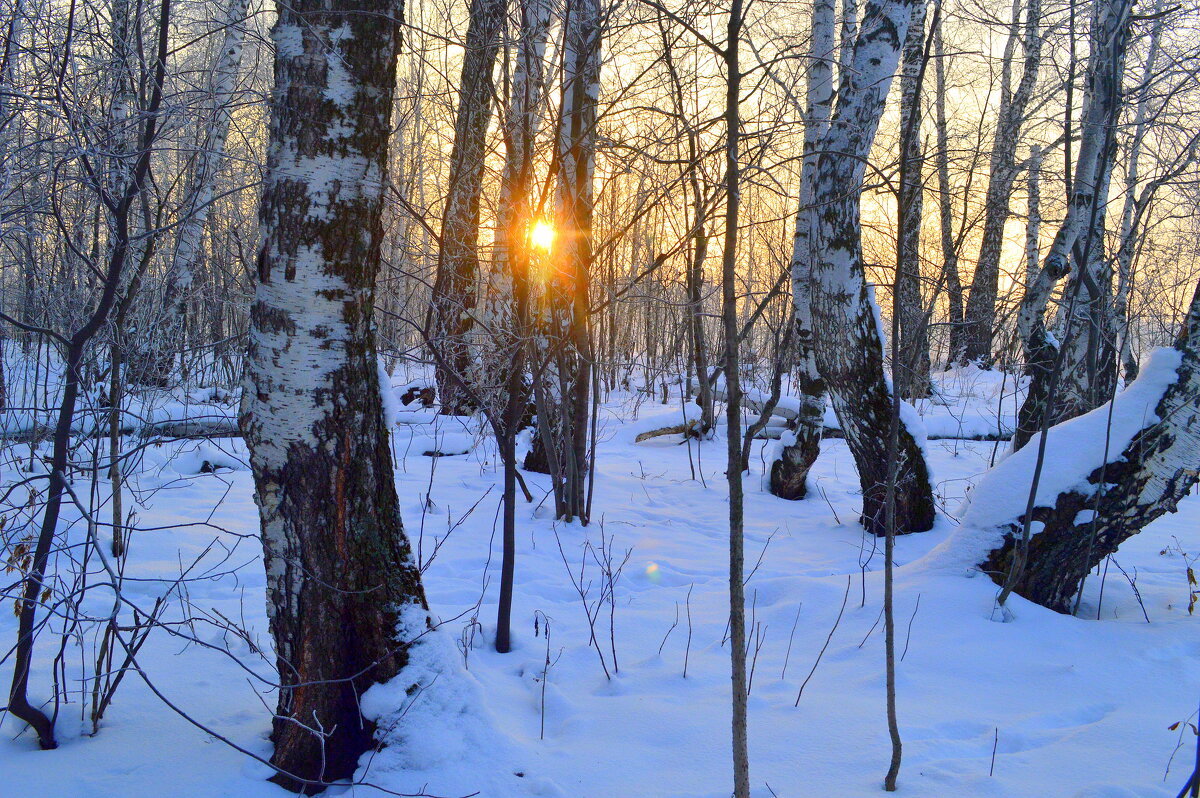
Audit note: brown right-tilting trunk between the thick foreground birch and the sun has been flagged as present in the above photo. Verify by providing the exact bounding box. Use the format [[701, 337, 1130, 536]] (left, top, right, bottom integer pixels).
[[430, 0, 506, 415]]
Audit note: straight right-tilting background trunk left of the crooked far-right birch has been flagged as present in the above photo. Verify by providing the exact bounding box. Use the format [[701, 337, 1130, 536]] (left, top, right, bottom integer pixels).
[[952, 0, 1042, 365]]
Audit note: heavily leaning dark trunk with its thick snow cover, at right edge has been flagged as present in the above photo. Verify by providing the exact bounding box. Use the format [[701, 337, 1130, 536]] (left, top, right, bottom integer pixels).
[[941, 288, 1200, 612]]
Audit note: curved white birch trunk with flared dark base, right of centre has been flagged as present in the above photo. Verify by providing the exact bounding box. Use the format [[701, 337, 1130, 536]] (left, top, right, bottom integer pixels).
[[812, 0, 935, 535]]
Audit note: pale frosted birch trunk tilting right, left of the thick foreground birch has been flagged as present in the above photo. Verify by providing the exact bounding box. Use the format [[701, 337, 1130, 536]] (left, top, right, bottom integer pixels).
[[150, 0, 250, 384]]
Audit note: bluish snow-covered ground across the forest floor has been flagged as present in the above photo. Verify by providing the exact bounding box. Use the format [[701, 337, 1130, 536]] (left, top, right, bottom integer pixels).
[[0, 373, 1200, 798]]
